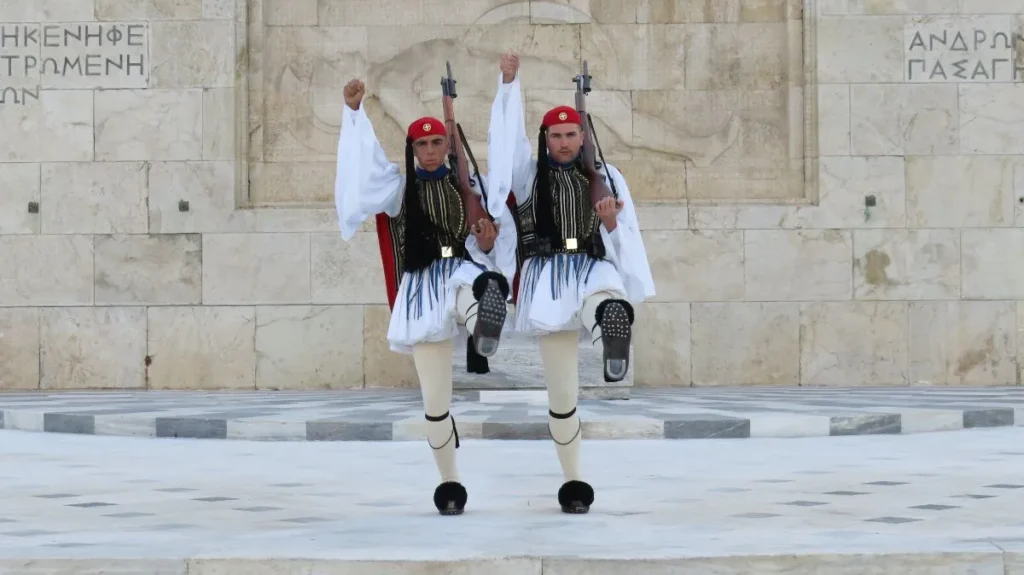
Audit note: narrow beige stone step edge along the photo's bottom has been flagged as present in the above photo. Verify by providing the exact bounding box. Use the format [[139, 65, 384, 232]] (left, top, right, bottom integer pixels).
[[0, 543, 1024, 575]]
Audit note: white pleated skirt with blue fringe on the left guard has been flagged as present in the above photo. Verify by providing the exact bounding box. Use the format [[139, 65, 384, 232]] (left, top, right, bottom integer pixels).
[[387, 258, 486, 354]]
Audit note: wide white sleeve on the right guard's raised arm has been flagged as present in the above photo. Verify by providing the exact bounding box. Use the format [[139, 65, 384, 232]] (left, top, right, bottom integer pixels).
[[487, 73, 537, 215]]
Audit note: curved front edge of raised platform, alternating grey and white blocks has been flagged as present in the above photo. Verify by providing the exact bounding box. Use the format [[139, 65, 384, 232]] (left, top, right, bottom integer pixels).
[[0, 407, 1024, 441]]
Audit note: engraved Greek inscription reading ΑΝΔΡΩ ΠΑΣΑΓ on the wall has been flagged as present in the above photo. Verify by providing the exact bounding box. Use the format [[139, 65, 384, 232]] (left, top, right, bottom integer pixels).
[[904, 15, 1024, 83]]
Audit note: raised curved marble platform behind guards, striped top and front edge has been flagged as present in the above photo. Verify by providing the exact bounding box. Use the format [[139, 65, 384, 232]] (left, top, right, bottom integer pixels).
[[0, 387, 1024, 441]]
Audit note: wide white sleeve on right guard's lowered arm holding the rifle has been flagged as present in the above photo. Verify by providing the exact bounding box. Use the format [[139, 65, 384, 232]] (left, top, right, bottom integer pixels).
[[599, 164, 654, 304]]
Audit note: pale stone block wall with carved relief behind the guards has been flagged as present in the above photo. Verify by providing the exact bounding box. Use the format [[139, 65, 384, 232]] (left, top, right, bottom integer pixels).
[[0, 0, 1024, 389]]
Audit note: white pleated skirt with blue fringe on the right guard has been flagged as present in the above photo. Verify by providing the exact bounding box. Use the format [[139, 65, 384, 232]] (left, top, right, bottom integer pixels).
[[514, 254, 626, 336]]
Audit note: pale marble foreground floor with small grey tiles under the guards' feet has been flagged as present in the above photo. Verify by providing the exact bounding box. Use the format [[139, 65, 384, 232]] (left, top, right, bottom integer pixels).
[[0, 428, 1024, 575]]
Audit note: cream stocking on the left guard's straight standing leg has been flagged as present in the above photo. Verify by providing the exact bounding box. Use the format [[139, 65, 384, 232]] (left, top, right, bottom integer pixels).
[[413, 337, 460, 482]]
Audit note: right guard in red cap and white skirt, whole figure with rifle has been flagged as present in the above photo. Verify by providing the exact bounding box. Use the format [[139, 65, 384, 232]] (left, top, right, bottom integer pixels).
[[487, 54, 654, 514]]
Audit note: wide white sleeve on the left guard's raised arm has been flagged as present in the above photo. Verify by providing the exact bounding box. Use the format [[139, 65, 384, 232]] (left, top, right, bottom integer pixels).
[[334, 103, 406, 240]]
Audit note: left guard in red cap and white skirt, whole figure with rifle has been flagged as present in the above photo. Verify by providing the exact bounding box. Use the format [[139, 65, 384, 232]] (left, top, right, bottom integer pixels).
[[335, 69, 516, 515]]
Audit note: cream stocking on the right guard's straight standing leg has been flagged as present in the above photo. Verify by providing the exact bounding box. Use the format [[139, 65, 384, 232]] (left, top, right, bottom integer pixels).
[[540, 329, 583, 481]]
